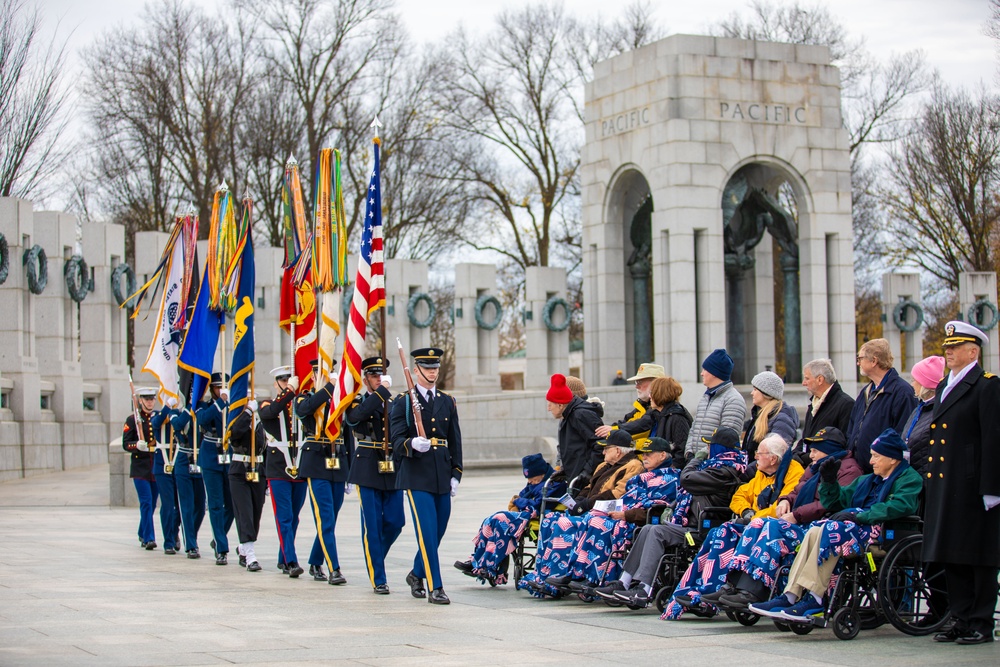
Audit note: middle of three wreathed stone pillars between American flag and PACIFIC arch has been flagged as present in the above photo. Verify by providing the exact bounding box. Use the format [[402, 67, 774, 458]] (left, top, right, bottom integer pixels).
[[454, 264, 500, 394]]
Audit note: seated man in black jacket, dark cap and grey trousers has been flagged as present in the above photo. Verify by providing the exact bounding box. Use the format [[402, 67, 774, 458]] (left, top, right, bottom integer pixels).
[[594, 428, 747, 609]]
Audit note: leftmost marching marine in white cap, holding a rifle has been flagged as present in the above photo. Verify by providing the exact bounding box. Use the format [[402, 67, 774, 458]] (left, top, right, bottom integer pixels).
[[122, 388, 157, 551]]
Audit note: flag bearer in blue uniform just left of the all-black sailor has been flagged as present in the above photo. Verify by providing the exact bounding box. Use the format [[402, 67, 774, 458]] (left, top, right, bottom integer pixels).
[[195, 373, 234, 565]]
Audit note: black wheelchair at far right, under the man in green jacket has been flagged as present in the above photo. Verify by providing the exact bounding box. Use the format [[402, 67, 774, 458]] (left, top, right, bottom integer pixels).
[[774, 516, 949, 640]]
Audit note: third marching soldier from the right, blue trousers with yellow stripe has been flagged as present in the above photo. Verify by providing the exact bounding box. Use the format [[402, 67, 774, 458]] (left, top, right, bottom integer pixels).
[[295, 362, 353, 585]]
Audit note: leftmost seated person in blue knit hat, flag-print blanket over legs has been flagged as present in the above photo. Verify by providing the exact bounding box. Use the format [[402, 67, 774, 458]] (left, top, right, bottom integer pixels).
[[455, 454, 566, 586]]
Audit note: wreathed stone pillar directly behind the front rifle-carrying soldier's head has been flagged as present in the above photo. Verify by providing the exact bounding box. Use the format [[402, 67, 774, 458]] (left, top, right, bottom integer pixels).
[[385, 259, 430, 366]]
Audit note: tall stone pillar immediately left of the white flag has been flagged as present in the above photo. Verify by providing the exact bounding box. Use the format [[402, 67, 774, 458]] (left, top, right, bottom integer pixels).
[[80, 222, 132, 465]]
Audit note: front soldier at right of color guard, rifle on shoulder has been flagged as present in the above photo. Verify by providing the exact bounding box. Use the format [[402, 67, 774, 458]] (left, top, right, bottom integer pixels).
[[389, 347, 462, 604]]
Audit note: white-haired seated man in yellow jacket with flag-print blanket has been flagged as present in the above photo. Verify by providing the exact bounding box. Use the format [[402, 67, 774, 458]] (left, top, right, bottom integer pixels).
[[663, 433, 803, 620]]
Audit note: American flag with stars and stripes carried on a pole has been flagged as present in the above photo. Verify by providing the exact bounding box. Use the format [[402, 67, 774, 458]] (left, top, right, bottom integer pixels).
[[326, 137, 385, 440]]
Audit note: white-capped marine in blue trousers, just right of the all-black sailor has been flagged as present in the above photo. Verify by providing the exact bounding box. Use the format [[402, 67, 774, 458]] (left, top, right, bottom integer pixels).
[[257, 366, 307, 579]]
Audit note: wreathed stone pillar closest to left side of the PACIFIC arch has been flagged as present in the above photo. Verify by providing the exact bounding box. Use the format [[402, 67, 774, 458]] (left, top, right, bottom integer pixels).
[[524, 266, 572, 389]]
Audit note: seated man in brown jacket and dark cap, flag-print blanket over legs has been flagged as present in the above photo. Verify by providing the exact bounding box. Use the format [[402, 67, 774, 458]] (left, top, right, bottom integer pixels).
[[518, 430, 656, 597]]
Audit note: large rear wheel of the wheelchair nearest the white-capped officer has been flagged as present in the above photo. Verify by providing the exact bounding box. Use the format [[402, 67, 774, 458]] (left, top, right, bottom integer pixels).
[[878, 535, 949, 636]]
